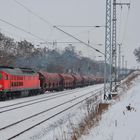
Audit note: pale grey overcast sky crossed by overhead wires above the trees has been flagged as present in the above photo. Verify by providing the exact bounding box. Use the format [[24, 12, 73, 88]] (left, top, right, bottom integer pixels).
[[0, 0, 140, 68]]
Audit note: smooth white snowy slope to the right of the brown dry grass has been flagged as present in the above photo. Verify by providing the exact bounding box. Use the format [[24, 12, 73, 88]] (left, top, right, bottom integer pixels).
[[80, 77, 140, 140]]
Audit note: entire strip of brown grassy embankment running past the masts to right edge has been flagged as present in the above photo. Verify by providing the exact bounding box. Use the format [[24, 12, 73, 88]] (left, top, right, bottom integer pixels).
[[66, 72, 140, 140]]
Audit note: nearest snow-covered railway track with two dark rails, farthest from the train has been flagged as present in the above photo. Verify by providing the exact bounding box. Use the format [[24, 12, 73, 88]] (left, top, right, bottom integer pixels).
[[0, 88, 103, 140]]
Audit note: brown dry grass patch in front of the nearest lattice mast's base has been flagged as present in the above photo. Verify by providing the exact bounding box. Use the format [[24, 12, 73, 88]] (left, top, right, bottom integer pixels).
[[71, 100, 109, 140]]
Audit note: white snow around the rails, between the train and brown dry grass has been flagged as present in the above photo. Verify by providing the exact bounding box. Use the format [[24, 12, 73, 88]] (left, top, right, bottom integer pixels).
[[0, 84, 103, 140]]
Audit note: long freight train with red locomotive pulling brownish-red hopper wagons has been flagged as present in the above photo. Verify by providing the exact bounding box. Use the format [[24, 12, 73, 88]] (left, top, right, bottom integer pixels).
[[0, 66, 104, 100]]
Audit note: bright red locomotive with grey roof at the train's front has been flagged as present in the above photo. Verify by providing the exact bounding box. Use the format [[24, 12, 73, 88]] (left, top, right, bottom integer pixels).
[[0, 66, 40, 99]]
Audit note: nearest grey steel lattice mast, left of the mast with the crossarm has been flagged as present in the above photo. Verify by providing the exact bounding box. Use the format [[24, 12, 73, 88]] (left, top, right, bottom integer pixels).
[[104, 0, 112, 99]]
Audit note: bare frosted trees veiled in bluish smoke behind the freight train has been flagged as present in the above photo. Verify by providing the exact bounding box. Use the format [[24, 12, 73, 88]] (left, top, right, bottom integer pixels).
[[0, 33, 104, 76]]
